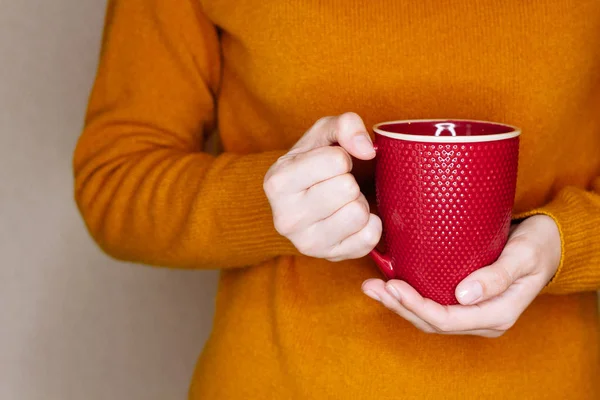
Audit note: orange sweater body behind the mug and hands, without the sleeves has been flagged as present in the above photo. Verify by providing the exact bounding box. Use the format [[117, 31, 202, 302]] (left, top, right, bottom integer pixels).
[[192, 0, 600, 399]]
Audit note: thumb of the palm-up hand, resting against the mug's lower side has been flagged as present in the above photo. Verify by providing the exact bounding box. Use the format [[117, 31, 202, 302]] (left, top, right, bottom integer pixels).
[[455, 254, 522, 305]]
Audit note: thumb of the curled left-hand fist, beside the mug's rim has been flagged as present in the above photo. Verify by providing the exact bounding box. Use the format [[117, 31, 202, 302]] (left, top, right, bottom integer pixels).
[[290, 112, 375, 160]]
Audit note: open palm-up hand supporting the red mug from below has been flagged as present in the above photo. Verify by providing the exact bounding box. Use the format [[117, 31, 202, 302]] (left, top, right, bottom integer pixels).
[[362, 215, 561, 337]]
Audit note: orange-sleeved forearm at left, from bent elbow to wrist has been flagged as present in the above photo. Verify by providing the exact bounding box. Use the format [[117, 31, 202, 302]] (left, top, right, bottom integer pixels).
[[76, 143, 294, 268]]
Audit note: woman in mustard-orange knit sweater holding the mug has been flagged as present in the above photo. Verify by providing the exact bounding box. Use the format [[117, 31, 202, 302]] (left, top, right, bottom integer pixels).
[[74, 0, 600, 399]]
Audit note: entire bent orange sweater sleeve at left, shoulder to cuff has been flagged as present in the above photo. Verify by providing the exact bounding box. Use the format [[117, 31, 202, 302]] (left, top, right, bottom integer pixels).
[[73, 0, 295, 268]]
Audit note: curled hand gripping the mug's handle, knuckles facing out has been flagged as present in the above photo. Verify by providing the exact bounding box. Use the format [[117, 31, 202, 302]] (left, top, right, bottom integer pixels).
[[264, 113, 381, 261]]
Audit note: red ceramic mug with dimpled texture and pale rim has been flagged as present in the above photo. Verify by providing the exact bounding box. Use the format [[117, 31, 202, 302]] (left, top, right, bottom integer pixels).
[[370, 119, 521, 305]]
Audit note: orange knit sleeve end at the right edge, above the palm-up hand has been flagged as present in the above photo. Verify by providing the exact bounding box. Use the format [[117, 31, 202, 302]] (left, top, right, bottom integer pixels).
[[516, 177, 600, 294]]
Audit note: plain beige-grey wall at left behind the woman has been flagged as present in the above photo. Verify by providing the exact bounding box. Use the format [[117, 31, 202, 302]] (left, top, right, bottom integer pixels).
[[0, 0, 220, 400]]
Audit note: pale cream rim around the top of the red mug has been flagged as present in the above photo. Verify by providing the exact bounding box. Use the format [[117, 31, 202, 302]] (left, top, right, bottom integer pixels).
[[373, 118, 521, 143]]
